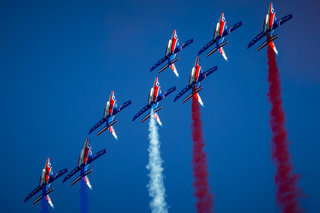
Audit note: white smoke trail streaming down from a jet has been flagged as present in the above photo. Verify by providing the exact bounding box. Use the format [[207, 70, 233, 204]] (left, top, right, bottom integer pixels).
[[147, 109, 168, 213]]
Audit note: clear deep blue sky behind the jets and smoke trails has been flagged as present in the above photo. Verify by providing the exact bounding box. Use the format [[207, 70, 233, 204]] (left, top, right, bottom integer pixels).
[[0, 0, 320, 213]]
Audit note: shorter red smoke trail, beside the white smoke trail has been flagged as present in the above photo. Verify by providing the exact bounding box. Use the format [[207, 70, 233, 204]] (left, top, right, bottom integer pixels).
[[191, 97, 214, 213]]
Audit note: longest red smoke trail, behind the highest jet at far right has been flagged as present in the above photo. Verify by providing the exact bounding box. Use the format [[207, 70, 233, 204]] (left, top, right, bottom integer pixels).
[[267, 47, 303, 213]]
